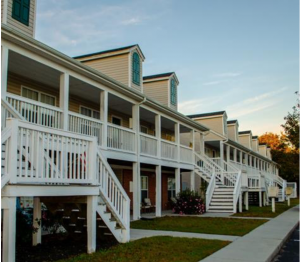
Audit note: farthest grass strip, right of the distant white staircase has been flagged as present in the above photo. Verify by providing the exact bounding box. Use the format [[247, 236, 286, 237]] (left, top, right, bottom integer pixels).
[[232, 199, 299, 218]]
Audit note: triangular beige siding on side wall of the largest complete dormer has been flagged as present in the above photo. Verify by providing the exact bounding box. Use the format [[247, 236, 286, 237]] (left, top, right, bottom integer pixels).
[[82, 54, 129, 85]]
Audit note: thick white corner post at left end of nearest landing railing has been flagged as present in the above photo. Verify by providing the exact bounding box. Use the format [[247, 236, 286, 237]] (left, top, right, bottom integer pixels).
[[6, 119, 18, 184]]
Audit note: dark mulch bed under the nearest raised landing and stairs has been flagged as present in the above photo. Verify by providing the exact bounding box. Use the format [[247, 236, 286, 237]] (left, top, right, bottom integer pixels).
[[16, 235, 118, 262]]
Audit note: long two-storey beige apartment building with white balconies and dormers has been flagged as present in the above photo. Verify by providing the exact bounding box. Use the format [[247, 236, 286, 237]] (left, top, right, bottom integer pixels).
[[1, 0, 292, 261]]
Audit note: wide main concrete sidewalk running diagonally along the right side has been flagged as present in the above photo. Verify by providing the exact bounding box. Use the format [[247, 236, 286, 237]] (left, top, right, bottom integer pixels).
[[201, 206, 299, 262]]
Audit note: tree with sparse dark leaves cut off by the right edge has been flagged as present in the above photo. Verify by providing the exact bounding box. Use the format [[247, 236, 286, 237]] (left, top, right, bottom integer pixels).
[[281, 92, 300, 151]]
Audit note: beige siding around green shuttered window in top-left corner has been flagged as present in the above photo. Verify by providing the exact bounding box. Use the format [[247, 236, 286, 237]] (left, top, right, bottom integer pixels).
[[7, 0, 36, 37]]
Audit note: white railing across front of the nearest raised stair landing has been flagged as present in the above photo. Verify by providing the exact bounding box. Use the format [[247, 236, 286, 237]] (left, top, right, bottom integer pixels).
[[6, 119, 97, 184]]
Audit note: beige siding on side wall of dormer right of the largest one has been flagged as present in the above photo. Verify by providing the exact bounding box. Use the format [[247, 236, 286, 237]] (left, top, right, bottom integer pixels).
[[144, 80, 169, 106]]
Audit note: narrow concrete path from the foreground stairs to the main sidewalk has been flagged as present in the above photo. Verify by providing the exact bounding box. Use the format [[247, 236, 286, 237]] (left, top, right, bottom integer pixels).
[[130, 229, 240, 242]]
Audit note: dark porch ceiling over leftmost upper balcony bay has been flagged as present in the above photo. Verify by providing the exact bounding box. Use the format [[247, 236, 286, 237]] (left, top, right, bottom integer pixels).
[[8, 51, 60, 89]]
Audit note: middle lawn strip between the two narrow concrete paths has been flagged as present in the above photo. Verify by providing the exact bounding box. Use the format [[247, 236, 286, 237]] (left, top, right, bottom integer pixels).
[[131, 216, 268, 236]]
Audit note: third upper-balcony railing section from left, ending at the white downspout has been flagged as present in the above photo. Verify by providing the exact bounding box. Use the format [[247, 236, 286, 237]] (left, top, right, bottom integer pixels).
[[107, 124, 135, 152]]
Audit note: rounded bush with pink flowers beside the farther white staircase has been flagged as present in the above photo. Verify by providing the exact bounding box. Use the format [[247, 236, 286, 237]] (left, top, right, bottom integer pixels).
[[173, 190, 205, 215]]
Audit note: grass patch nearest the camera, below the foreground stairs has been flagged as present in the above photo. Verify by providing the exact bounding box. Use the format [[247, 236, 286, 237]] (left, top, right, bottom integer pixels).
[[59, 236, 230, 262]]
